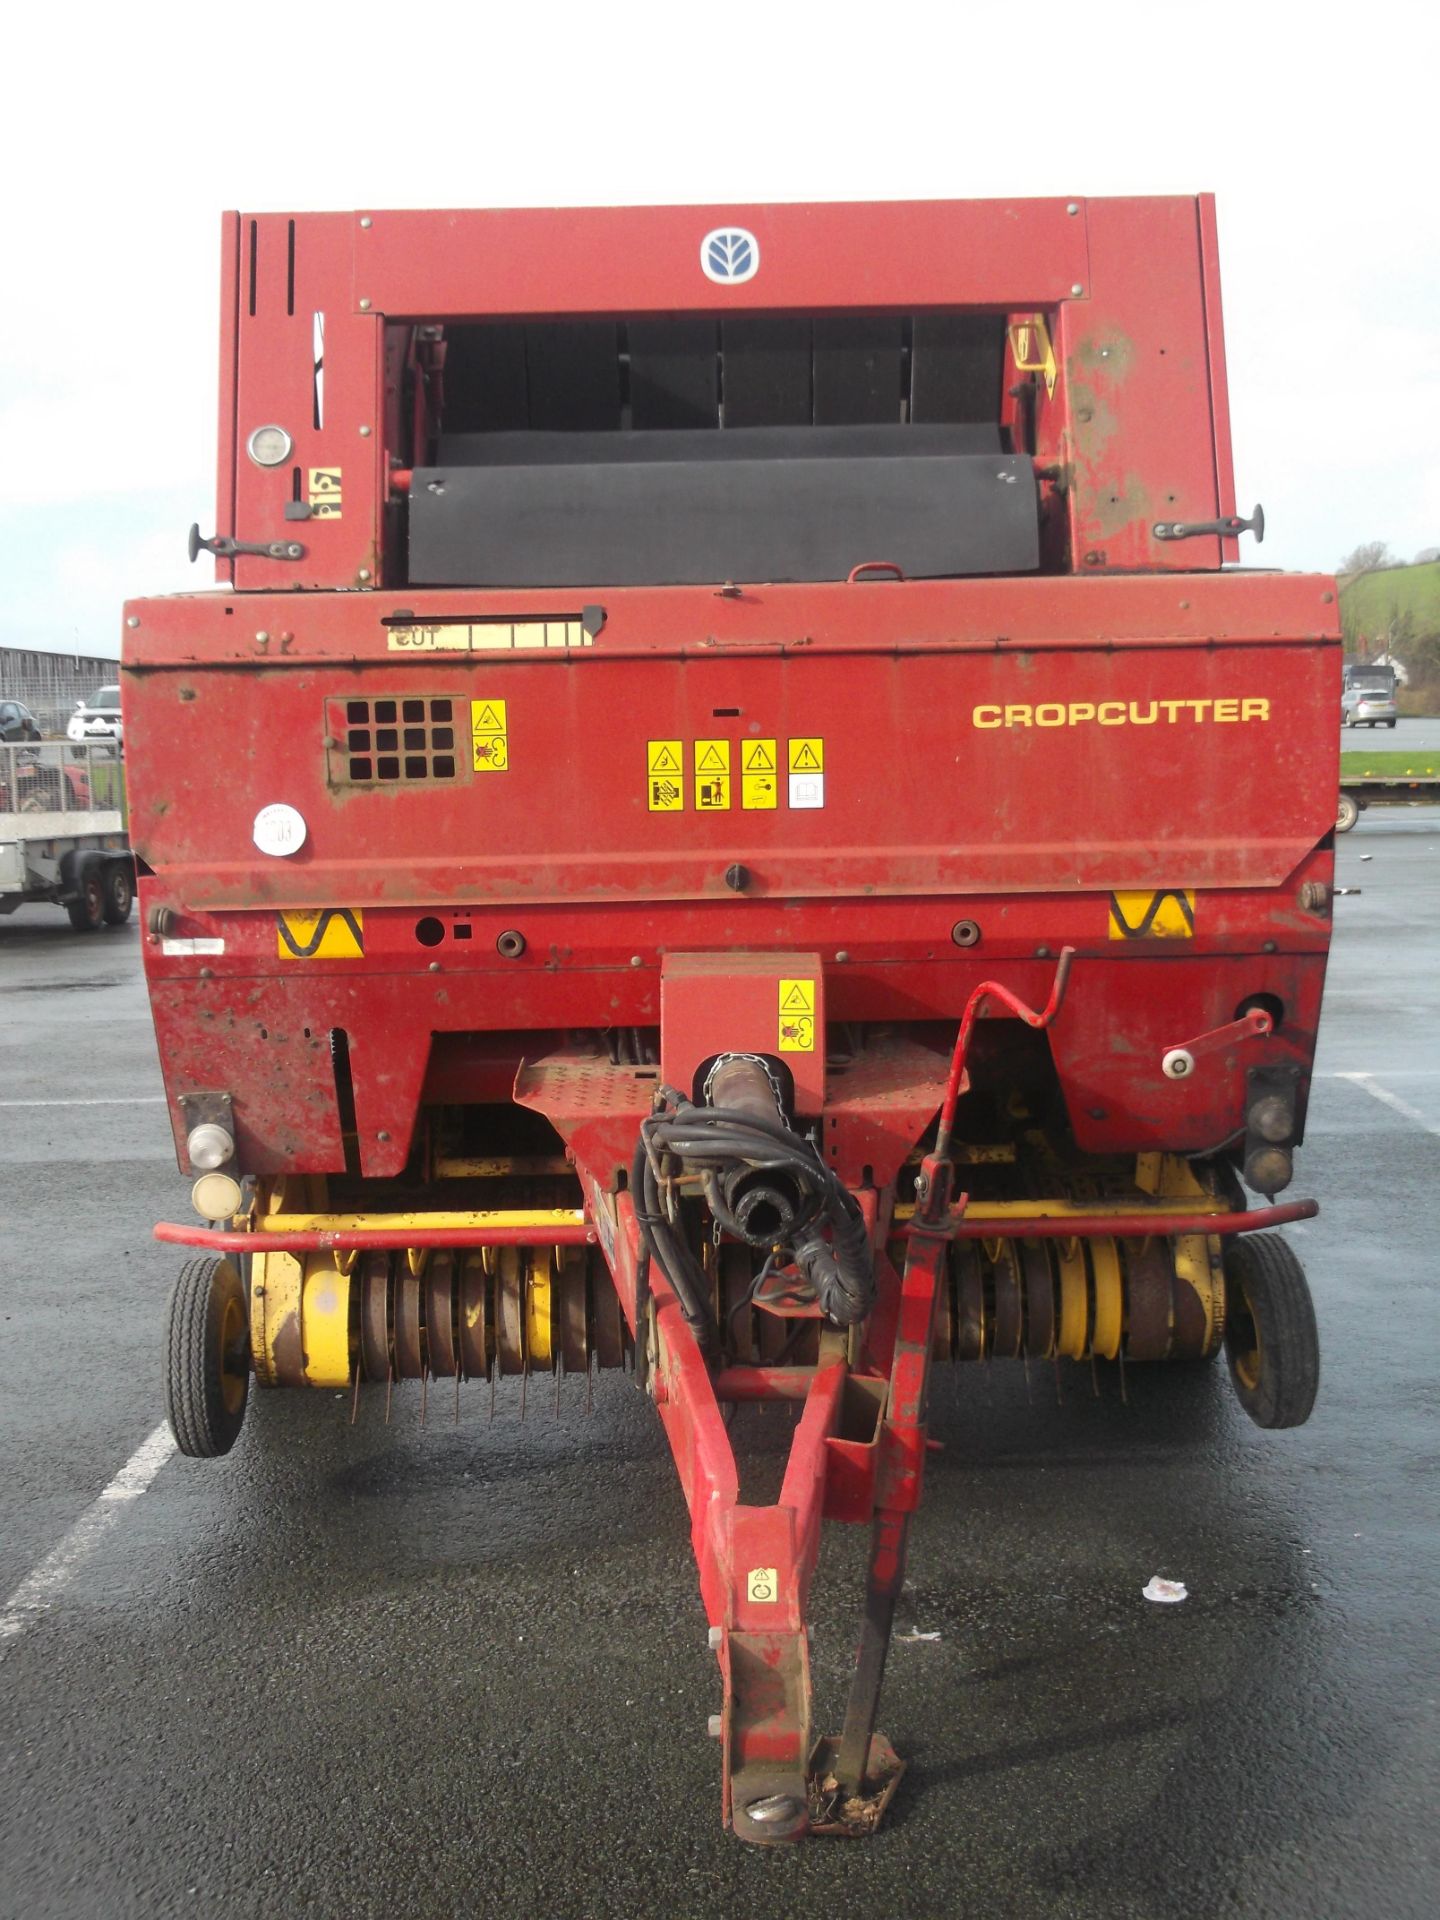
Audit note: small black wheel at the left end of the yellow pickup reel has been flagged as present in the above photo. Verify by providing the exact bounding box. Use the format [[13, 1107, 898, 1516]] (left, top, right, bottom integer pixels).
[[165, 1254, 250, 1459]]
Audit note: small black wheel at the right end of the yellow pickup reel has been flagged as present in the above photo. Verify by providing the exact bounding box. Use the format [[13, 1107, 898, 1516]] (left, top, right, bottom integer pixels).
[[1225, 1233, 1319, 1428]]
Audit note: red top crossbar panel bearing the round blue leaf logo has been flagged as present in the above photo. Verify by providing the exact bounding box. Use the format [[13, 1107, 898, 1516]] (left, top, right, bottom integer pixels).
[[349, 200, 1090, 319]]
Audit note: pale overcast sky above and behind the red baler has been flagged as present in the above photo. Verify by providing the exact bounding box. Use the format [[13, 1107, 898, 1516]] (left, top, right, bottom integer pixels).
[[0, 0, 1440, 653]]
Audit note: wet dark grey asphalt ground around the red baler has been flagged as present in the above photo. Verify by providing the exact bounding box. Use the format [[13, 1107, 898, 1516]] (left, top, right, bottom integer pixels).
[[0, 808, 1440, 1920]]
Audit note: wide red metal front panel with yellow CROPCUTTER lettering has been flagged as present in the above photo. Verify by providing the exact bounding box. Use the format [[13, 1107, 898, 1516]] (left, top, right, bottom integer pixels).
[[127, 576, 1340, 910]]
